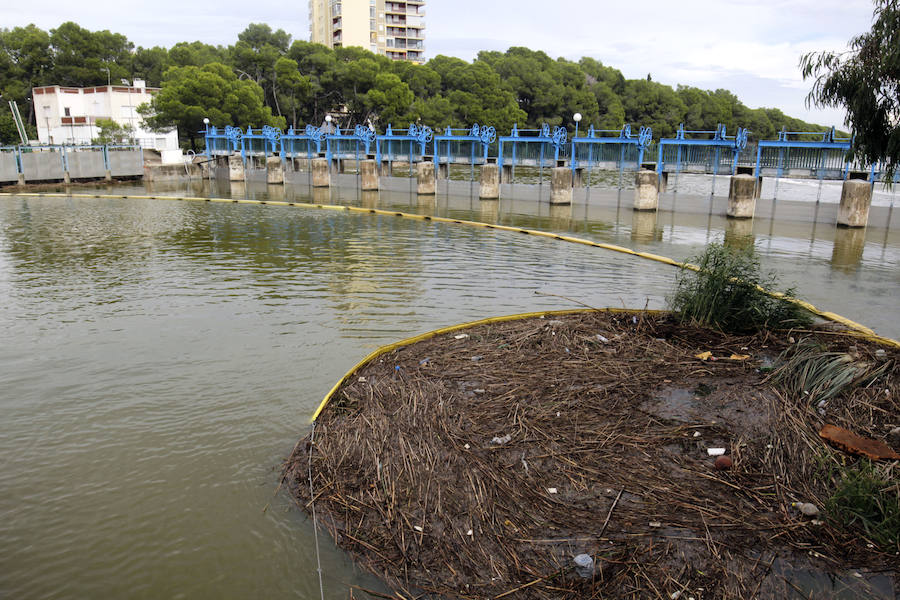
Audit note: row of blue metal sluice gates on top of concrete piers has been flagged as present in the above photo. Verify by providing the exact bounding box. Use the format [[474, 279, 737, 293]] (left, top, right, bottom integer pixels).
[[203, 118, 900, 182]]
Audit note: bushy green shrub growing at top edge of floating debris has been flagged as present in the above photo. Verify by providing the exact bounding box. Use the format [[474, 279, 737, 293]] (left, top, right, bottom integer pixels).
[[669, 242, 812, 333]]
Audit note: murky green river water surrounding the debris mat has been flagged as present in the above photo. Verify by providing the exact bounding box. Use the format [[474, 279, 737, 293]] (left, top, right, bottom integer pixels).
[[0, 176, 900, 598]]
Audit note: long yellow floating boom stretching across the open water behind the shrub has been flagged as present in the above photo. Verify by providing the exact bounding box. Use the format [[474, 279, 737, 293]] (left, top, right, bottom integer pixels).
[[7, 192, 900, 358]]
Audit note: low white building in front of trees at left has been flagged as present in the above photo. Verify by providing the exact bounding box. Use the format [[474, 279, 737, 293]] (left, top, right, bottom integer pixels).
[[31, 79, 179, 151]]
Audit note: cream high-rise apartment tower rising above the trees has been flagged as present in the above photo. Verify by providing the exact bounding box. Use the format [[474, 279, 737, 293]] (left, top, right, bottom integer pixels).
[[309, 0, 425, 63]]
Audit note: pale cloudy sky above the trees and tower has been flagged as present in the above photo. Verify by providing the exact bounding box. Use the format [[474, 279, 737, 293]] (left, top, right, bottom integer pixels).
[[0, 0, 873, 127]]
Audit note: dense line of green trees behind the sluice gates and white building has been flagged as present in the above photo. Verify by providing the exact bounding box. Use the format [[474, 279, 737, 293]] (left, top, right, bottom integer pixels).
[[0, 22, 836, 143]]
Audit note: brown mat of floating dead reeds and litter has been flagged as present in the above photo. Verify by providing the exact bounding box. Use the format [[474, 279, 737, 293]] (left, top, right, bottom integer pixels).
[[285, 311, 900, 600]]
